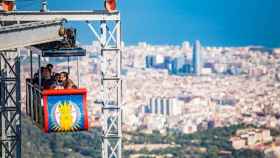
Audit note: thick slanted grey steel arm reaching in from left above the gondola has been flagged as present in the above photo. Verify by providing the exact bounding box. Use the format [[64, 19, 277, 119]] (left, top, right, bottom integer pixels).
[[0, 21, 62, 51]]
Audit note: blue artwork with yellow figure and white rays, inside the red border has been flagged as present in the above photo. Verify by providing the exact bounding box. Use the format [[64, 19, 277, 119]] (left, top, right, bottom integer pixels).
[[45, 95, 85, 132]]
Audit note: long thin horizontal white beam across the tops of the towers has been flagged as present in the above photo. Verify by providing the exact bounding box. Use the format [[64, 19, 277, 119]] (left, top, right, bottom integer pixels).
[[0, 10, 120, 21]]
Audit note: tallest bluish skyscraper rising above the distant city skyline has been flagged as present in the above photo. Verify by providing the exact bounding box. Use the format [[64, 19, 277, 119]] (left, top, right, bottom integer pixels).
[[192, 40, 203, 76]]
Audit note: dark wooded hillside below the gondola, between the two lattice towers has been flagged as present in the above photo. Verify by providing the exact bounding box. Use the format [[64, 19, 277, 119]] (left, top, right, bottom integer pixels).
[[22, 116, 101, 158]]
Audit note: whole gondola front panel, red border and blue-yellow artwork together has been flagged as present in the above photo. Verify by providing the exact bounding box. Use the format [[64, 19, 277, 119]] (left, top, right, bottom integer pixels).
[[43, 89, 88, 133]]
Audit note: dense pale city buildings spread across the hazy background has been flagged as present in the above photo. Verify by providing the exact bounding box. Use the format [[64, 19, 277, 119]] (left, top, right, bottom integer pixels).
[[19, 42, 280, 157]]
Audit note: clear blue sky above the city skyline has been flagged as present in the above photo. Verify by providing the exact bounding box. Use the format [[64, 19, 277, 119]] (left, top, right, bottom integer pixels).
[[18, 0, 280, 47]]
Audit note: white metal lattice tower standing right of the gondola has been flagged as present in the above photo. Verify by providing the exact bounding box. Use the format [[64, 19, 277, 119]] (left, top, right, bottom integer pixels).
[[101, 21, 122, 158]]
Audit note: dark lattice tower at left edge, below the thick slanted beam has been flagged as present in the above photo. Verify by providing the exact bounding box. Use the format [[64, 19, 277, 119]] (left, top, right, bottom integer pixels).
[[0, 51, 21, 158]]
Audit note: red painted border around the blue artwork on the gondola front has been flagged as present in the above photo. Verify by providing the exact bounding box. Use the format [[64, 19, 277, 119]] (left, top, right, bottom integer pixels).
[[42, 88, 89, 133]]
